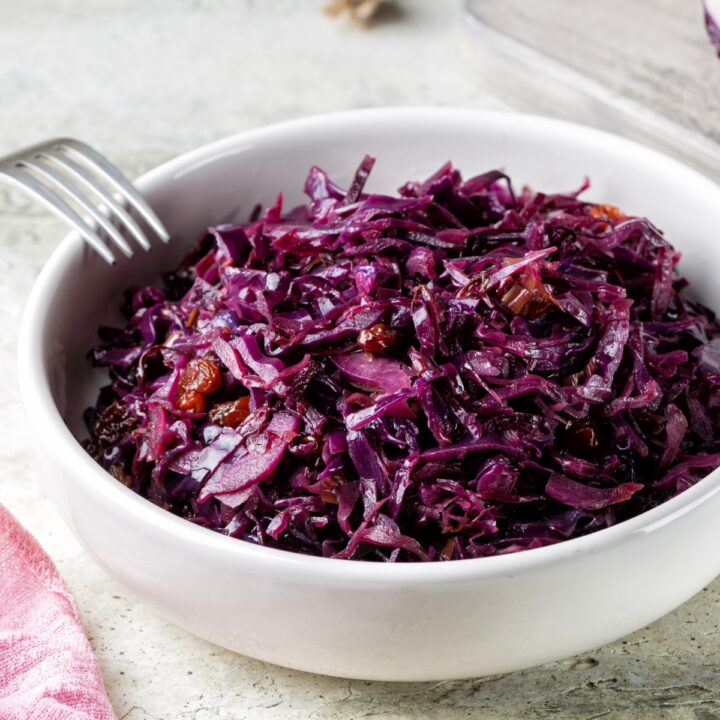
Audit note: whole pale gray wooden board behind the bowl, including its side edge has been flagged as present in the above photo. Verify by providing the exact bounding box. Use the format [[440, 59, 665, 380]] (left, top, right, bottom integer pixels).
[[464, 0, 720, 180]]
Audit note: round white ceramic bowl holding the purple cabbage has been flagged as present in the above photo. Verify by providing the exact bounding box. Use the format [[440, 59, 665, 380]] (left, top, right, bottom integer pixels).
[[20, 109, 720, 680]]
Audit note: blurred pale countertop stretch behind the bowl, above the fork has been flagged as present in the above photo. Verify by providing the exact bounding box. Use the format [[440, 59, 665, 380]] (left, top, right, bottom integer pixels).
[[0, 0, 502, 170]]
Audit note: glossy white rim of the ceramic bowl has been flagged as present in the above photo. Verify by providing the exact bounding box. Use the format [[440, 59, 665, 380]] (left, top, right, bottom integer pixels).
[[18, 107, 720, 585]]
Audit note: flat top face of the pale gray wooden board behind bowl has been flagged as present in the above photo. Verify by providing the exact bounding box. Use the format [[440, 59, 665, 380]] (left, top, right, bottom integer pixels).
[[468, 0, 720, 141]]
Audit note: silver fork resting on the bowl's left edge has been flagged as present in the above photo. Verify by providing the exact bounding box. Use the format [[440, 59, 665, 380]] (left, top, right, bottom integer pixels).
[[0, 138, 170, 264]]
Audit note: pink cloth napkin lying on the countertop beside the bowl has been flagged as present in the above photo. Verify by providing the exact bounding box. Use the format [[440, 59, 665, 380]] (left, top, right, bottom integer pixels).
[[0, 505, 115, 720]]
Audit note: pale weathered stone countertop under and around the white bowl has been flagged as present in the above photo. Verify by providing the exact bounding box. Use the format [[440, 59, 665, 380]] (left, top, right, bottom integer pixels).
[[0, 0, 720, 720]]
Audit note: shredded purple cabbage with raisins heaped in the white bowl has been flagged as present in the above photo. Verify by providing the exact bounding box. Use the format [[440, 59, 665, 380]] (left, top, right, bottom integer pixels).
[[87, 157, 720, 562]]
